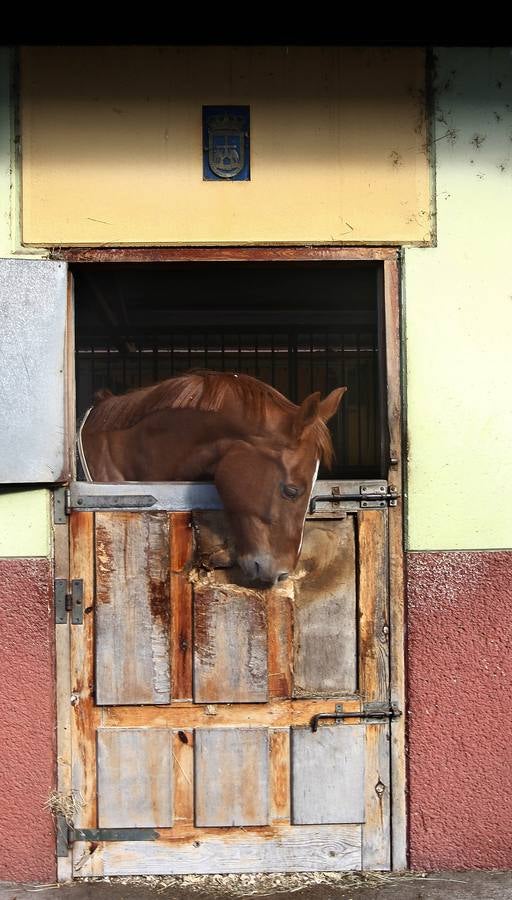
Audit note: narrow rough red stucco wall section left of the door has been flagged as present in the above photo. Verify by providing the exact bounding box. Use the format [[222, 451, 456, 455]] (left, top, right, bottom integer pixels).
[[0, 559, 55, 881]]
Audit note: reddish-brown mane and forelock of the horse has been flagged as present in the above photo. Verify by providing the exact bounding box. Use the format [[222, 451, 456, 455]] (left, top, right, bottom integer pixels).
[[87, 371, 334, 468]]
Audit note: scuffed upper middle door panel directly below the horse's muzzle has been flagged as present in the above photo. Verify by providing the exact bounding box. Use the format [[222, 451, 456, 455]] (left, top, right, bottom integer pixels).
[[194, 585, 268, 703]]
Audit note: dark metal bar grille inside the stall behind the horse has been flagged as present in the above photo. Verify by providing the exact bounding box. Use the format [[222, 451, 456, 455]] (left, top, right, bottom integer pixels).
[[76, 329, 379, 474]]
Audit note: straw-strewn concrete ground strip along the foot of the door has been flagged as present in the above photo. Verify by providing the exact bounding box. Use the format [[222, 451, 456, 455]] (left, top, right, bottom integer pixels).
[[0, 870, 512, 900]]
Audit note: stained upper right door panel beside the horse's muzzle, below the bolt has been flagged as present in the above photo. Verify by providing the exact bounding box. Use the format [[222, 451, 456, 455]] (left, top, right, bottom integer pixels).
[[294, 516, 357, 697]]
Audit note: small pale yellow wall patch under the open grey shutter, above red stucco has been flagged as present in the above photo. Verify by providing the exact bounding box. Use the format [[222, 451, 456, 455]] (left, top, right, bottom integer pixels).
[[0, 488, 51, 557]]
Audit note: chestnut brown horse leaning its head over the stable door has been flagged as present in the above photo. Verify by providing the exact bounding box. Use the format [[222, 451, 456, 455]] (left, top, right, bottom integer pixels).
[[82, 372, 346, 584]]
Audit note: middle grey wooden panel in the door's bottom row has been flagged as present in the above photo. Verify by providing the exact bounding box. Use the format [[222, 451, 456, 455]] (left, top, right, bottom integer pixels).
[[194, 728, 269, 826]]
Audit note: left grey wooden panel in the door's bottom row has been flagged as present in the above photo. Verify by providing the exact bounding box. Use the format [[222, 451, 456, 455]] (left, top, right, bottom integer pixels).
[[98, 728, 172, 828]]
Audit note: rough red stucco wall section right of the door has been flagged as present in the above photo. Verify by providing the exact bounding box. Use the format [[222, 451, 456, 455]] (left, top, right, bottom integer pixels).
[[408, 552, 512, 868]]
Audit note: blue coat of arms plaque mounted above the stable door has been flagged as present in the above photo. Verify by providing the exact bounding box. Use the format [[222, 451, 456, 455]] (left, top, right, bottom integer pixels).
[[205, 107, 249, 180]]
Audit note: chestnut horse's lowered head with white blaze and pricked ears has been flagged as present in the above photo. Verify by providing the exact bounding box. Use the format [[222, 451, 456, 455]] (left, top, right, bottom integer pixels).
[[215, 387, 346, 586]]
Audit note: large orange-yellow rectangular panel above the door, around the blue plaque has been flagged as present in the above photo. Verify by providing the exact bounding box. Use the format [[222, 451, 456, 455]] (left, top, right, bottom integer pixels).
[[22, 47, 431, 245]]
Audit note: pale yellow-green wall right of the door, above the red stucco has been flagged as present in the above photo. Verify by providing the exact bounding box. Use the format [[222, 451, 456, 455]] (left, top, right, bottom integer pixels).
[[405, 48, 512, 550]]
